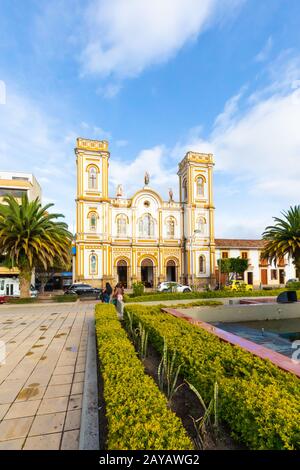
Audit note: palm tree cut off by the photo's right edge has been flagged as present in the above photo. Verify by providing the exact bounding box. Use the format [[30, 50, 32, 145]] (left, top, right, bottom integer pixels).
[[262, 205, 300, 277]]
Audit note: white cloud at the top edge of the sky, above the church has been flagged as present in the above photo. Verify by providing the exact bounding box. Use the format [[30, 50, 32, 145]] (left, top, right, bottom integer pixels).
[[81, 0, 243, 78]]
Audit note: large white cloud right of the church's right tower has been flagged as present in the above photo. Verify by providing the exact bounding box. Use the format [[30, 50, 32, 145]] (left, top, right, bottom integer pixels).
[[172, 58, 300, 237]]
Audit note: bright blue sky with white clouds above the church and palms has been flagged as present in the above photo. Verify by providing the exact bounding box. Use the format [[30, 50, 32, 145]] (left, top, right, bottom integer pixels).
[[0, 0, 300, 238]]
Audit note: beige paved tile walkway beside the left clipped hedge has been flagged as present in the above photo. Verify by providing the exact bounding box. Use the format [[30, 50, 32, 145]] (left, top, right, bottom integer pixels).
[[0, 303, 94, 449]]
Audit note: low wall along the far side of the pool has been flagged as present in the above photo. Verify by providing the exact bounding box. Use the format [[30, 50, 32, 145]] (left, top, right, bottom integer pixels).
[[176, 302, 300, 323]]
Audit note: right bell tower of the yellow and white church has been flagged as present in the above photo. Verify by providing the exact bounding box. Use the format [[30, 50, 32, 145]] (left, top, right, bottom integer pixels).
[[178, 152, 215, 285]]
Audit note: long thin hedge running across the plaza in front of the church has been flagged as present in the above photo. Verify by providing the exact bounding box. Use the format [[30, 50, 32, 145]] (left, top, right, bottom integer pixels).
[[124, 289, 300, 303]]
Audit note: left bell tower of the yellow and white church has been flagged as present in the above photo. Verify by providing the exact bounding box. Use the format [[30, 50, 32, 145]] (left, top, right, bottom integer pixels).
[[75, 138, 109, 286]]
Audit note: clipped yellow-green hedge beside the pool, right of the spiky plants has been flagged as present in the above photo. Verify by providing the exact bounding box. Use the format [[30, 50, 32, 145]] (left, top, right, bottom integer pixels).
[[125, 305, 300, 449]]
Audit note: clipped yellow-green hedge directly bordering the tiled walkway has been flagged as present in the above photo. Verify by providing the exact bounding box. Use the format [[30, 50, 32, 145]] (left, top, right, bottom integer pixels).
[[96, 304, 193, 450]]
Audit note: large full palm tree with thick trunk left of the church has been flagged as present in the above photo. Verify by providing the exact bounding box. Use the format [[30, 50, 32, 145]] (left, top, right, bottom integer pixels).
[[0, 195, 72, 297]]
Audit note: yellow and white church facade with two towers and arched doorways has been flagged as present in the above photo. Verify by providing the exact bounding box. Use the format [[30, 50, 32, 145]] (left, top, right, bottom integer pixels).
[[74, 138, 216, 287]]
